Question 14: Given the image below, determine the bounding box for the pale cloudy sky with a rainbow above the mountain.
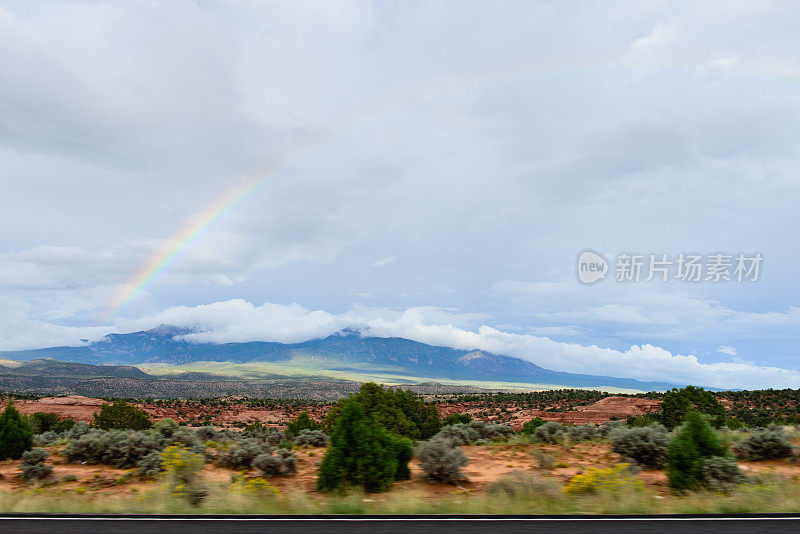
[0,0,800,388]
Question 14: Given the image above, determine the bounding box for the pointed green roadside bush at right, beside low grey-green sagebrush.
[667,412,727,493]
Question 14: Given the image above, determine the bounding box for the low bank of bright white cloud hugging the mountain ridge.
[108,300,800,388]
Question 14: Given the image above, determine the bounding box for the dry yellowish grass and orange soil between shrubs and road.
[0,440,800,514]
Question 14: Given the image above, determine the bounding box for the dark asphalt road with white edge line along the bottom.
[0,516,800,534]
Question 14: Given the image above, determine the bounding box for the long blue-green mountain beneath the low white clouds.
[0,326,676,390]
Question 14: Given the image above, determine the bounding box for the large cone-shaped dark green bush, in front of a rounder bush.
[317,399,410,492]
